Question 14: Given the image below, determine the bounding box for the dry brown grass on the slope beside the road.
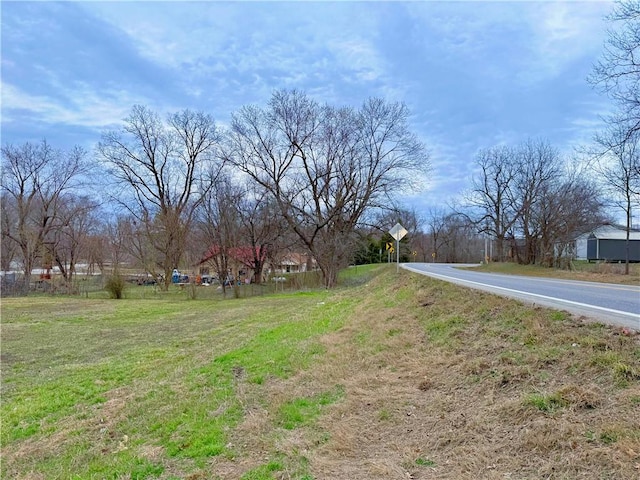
[215,276,640,480]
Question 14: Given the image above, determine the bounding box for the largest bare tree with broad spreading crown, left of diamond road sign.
[225,91,428,287]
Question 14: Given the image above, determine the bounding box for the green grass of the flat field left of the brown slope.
[0,269,365,478]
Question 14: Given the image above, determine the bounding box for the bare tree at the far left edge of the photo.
[2,140,88,286]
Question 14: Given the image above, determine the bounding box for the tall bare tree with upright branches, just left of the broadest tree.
[98,105,220,288]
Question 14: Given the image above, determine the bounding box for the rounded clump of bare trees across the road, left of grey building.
[464,140,603,266]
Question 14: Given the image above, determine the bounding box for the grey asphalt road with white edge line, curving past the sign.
[401,263,640,330]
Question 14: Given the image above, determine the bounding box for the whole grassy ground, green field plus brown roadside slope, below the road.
[0,266,640,480]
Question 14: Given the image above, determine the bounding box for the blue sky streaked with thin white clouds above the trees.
[0,1,613,210]
